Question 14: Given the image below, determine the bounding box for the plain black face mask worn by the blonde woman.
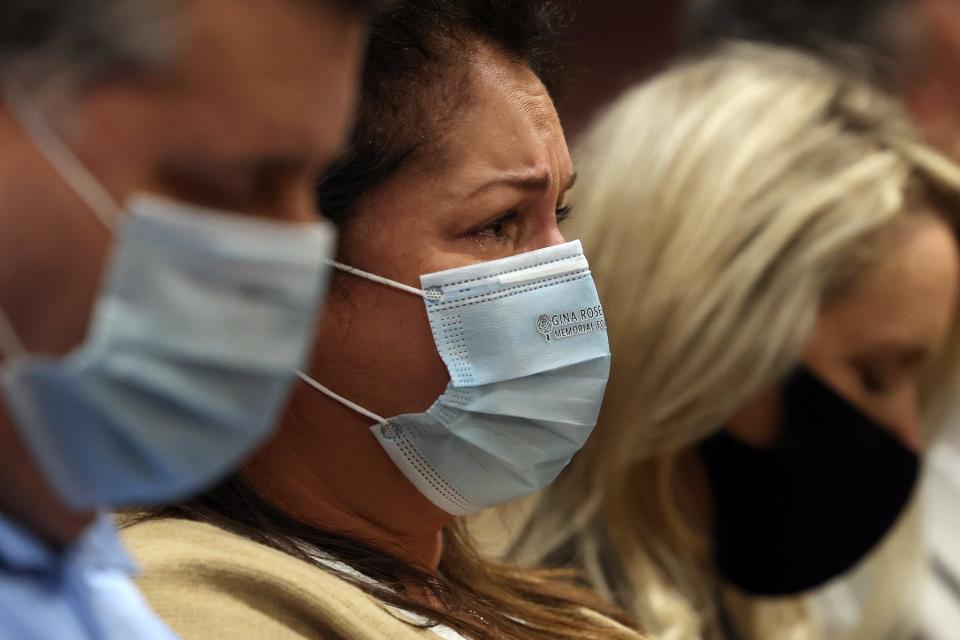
[698,367,920,596]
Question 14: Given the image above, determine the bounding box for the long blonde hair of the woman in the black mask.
[513,43,960,640]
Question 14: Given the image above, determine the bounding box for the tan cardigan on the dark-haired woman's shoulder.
[122,519,640,640]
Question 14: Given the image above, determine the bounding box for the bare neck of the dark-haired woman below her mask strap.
[243,390,452,571]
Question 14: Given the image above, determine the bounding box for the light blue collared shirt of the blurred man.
[0,516,176,640]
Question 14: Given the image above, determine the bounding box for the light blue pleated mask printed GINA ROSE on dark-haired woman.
[301,241,610,515]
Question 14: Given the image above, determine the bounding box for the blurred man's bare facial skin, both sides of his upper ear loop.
[0,0,365,353]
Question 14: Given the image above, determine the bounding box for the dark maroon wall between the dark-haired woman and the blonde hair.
[558,0,681,137]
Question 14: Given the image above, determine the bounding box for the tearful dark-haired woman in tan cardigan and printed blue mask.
[126,0,637,640]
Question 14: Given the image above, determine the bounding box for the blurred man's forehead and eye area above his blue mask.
[65,0,363,220]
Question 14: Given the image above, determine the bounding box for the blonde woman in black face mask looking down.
[502,44,960,640]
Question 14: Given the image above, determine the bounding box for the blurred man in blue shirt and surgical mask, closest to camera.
[0,0,388,640]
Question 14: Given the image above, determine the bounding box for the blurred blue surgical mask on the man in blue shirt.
[0,89,335,509]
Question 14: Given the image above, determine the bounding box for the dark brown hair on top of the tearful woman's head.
[317,0,567,225]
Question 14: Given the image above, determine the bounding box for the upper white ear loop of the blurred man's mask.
[5,86,120,232]
